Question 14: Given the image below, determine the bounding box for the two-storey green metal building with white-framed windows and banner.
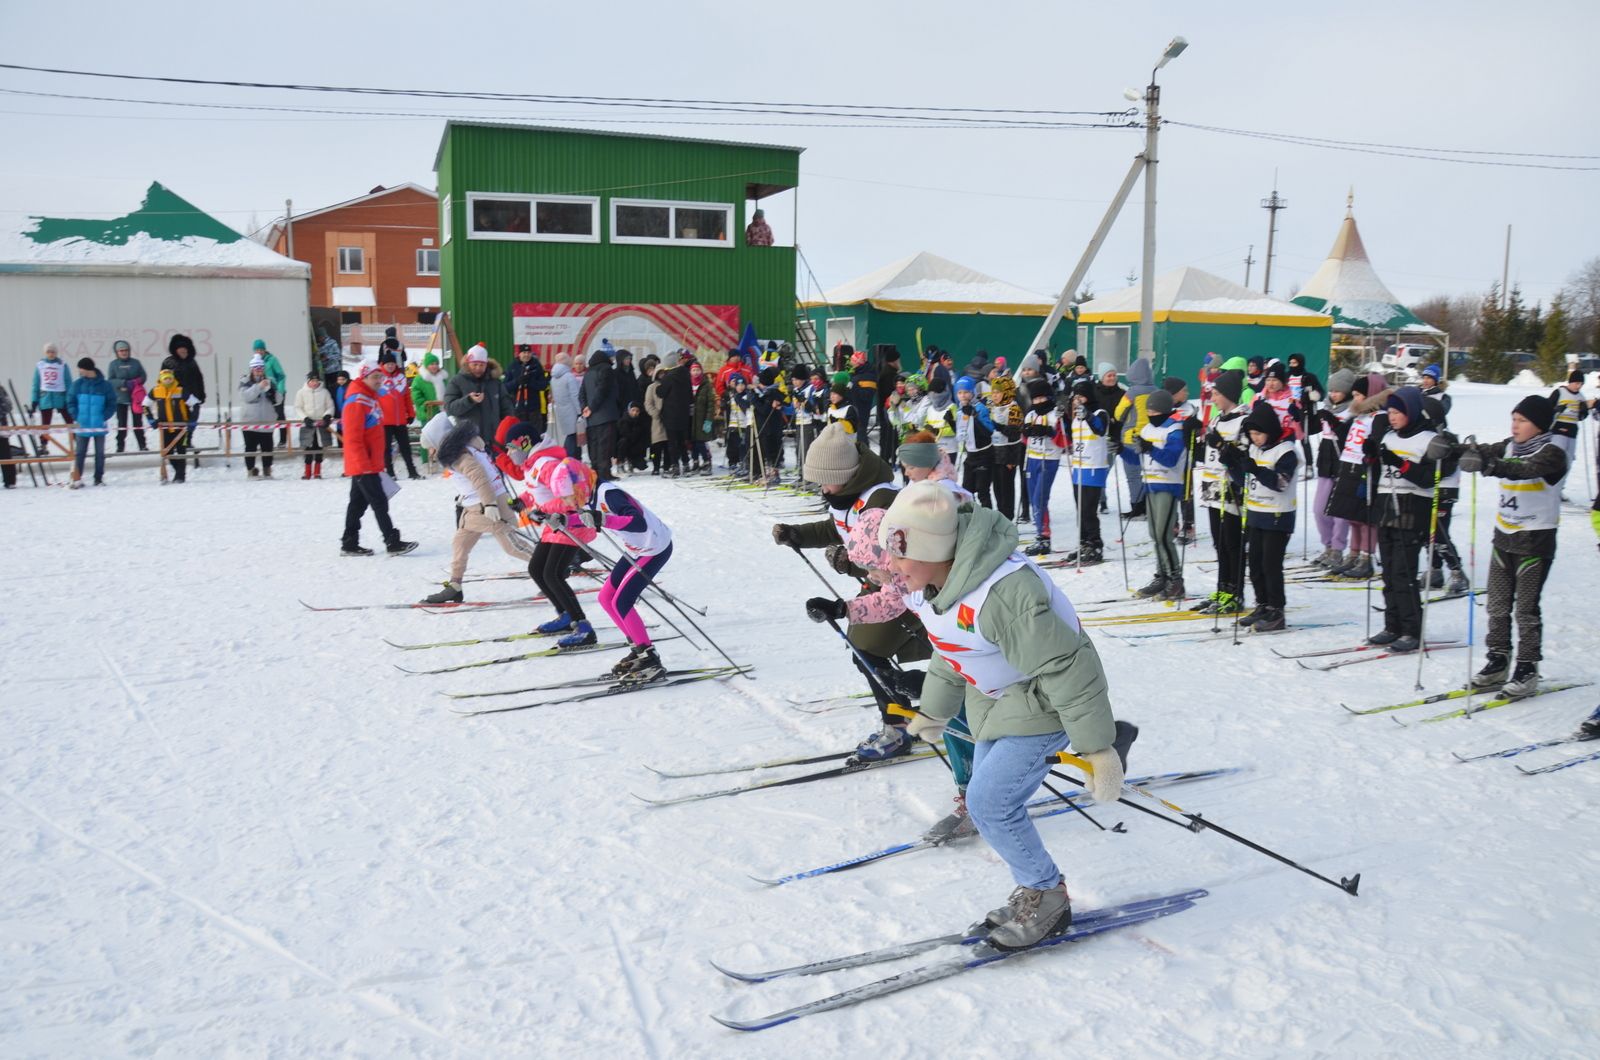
[434,122,802,362]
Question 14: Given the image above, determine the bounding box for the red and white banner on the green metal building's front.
[510,303,739,365]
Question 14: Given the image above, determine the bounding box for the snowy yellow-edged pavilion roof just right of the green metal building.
[805,251,1054,317]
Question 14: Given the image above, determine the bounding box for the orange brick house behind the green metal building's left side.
[266,184,438,325]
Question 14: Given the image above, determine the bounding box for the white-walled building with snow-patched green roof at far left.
[0,184,310,408]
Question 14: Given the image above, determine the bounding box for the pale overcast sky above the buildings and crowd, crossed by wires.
[0,0,1600,313]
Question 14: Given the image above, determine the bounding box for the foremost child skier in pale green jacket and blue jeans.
[878,486,1125,950]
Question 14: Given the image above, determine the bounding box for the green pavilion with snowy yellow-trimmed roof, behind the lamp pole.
[1077,269,1333,381]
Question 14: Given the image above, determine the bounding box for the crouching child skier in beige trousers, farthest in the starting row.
[422,415,533,604]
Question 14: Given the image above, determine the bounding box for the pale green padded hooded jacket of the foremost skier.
[912,506,1115,754]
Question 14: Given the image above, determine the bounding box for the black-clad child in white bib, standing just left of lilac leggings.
[1222,402,1299,632]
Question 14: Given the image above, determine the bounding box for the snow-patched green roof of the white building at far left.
[0,183,309,277]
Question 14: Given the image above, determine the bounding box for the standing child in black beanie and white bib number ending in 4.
[1429,395,1568,697]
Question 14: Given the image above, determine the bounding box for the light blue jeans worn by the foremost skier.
[966,732,1069,890]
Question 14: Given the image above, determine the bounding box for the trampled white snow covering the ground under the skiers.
[0,386,1600,1057]
